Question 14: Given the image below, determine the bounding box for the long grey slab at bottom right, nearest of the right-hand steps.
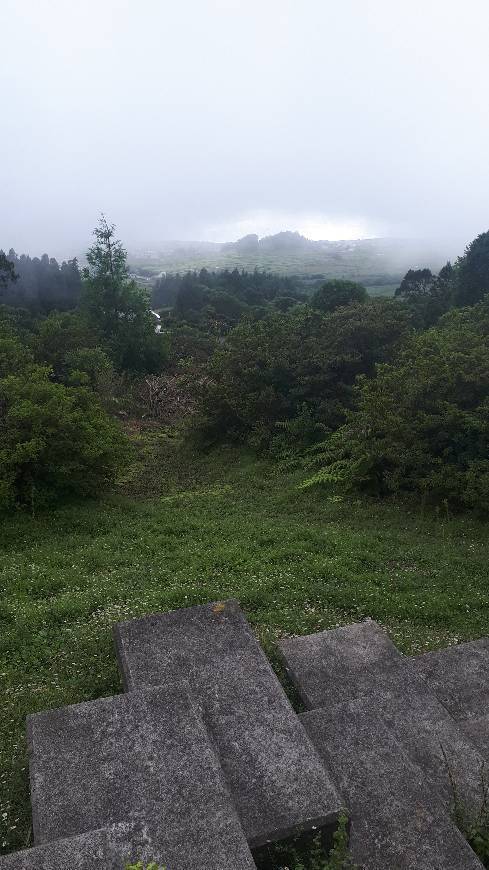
[300,698,482,870]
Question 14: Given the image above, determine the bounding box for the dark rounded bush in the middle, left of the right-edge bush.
[200,300,409,443]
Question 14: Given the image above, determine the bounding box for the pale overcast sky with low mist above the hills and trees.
[0,0,489,254]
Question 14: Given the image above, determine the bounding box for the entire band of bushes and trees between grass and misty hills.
[0,217,489,510]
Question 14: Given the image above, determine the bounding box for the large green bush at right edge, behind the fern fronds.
[308,302,489,511]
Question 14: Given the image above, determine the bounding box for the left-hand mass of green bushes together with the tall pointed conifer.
[0,218,166,511]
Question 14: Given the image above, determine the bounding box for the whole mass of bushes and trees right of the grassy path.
[195,232,489,511]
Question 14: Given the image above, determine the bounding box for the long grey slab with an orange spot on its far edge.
[115,601,342,848]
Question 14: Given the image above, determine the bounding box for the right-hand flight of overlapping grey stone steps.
[280,620,489,870]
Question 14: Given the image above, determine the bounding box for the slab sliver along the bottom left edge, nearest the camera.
[0,818,255,870]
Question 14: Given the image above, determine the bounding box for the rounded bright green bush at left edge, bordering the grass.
[0,366,129,509]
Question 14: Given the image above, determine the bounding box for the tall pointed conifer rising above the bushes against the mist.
[82,215,166,372]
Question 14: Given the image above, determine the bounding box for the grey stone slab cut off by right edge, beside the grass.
[412,637,489,719]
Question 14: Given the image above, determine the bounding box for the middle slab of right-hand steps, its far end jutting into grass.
[280,621,484,811]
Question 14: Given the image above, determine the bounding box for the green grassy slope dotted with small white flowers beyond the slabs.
[0,439,489,851]
